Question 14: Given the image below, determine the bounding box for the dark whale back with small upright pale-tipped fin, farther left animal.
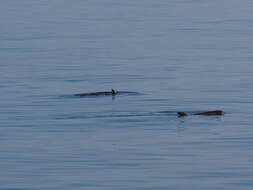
[74,88,139,97]
